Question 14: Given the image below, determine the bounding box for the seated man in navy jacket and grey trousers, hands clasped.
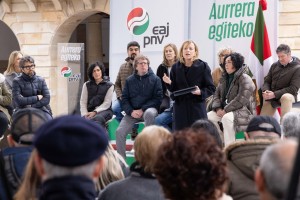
[116,55,163,158]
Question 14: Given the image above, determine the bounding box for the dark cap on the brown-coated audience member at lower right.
[246,116,281,136]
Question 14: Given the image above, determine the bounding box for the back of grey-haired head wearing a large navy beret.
[33,115,108,180]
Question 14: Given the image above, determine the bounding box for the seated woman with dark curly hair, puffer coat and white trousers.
[207,53,256,146]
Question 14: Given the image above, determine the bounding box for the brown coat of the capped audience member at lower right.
[225,139,276,200]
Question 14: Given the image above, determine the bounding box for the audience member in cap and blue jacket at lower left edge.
[0,108,47,199]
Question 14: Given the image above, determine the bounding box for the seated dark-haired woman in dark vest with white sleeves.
[80,62,114,127]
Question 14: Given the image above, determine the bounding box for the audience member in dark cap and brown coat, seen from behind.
[225,116,281,200]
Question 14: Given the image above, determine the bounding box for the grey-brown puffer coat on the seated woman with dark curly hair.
[212,65,256,132]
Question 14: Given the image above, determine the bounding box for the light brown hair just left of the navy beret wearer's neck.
[14,150,41,200]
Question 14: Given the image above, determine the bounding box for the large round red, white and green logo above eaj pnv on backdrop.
[127,7,149,35]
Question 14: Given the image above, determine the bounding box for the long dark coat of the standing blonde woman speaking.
[167,59,215,130]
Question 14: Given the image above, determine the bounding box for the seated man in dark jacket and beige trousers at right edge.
[260,44,300,120]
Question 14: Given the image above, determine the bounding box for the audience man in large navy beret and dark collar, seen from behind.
[34,115,108,200]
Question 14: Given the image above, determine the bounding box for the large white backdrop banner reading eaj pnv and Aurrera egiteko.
[109,0,278,82]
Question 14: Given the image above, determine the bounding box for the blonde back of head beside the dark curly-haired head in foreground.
[134,125,171,173]
